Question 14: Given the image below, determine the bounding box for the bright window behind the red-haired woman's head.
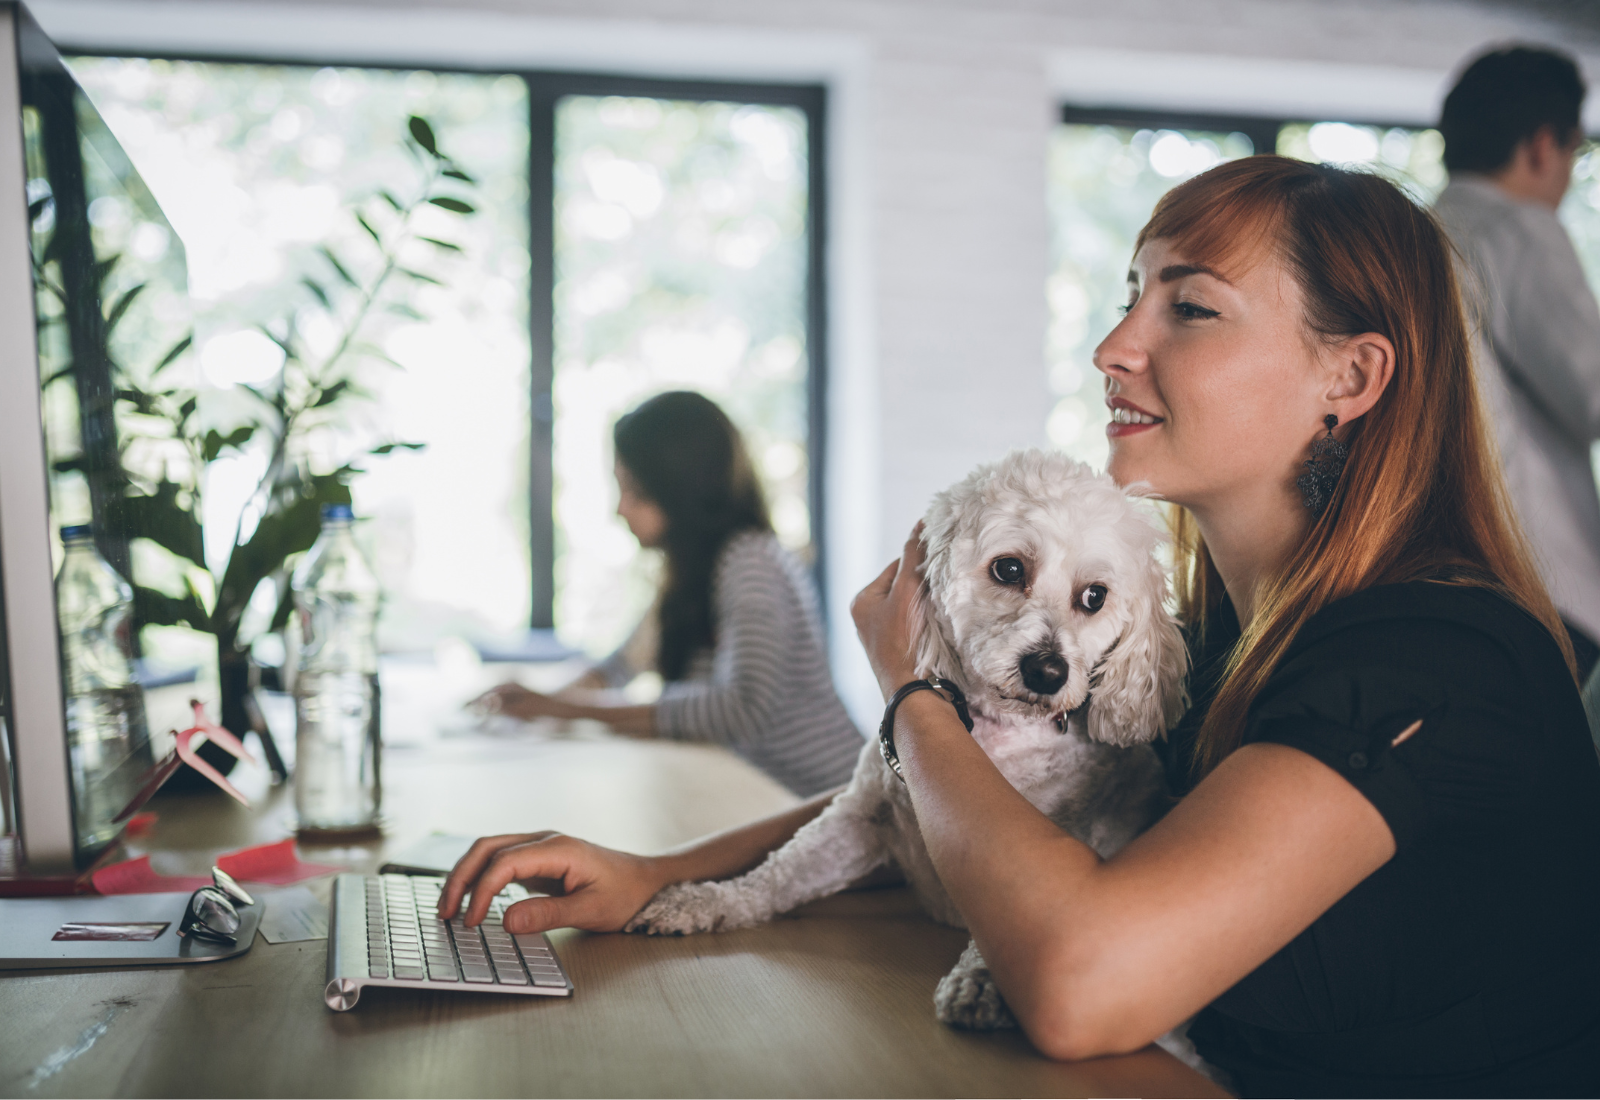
[1046,107,1600,465]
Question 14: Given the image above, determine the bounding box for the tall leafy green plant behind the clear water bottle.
[117,117,474,788]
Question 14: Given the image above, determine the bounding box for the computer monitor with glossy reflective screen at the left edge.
[0,0,190,876]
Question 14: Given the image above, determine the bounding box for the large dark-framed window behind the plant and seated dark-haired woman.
[72,58,822,665]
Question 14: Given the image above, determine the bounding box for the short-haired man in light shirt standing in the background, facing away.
[1435,46,1600,676]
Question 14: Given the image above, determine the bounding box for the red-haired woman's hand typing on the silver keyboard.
[438,831,667,934]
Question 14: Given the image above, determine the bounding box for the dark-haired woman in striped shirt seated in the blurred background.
[474,390,862,796]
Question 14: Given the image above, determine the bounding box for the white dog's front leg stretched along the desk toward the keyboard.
[624,787,890,935]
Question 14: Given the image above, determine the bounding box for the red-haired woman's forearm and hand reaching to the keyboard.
[438,788,842,932]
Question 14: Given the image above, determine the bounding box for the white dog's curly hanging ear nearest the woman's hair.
[1088,555,1189,745]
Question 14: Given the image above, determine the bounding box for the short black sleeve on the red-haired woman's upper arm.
[1243,620,1538,849]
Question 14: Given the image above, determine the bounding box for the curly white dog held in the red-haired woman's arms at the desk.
[627,451,1187,1028]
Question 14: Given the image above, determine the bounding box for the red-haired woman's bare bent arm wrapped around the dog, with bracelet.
[851,534,1395,1058]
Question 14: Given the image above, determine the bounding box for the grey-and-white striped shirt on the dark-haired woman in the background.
[600,531,862,796]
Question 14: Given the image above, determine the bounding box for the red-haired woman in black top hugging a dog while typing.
[440,155,1600,1097]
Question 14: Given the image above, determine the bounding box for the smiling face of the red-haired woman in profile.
[1094,240,1330,510]
